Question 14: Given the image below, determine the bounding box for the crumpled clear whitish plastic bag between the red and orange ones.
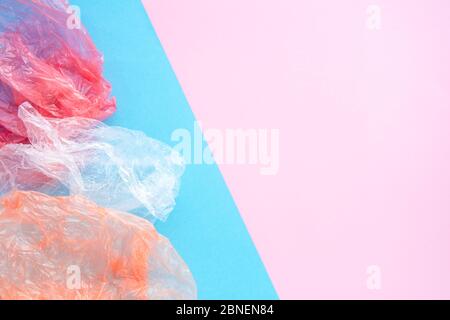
[0,103,184,220]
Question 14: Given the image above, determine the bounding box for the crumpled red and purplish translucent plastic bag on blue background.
[0,0,116,146]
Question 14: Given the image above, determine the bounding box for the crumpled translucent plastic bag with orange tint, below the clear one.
[0,191,196,300]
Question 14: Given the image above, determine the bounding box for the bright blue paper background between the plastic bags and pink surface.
[71,0,278,299]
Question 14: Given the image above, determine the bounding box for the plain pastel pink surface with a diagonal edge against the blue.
[143,0,450,299]
